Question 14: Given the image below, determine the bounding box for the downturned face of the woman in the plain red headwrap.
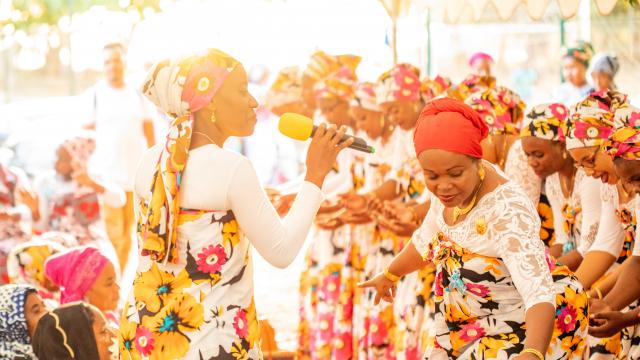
[418,149,479,208]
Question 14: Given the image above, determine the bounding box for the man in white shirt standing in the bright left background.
[88,43,155,271]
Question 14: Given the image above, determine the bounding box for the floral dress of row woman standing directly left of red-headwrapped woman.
[354,129,434,359]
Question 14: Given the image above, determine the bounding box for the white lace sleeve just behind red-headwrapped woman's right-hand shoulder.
[504,140,542,206]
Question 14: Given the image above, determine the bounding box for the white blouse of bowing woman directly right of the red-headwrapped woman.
[545,169,600,256]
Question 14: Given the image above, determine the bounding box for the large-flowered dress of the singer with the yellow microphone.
[120,203,261,359]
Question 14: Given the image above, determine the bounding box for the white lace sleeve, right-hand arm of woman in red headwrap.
[487,185,556,309]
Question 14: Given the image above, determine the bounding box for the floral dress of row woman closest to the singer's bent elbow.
[298,148,358,359]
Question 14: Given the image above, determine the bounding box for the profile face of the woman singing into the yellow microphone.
[209,65,258,137]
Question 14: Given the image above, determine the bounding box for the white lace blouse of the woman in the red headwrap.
[412,182,557,309]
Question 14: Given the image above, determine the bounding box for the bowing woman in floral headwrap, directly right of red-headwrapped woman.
[520,104,601,258]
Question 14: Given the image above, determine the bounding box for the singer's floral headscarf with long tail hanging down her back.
[141,49,240,263]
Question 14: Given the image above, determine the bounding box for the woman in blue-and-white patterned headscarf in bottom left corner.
[0,285,47,360]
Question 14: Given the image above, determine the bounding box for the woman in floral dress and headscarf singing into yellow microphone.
[119,49,351,359]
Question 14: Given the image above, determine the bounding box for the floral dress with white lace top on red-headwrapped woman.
[412,183,588,360]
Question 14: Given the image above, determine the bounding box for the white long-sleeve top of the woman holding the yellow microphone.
[135,144,323,268]
